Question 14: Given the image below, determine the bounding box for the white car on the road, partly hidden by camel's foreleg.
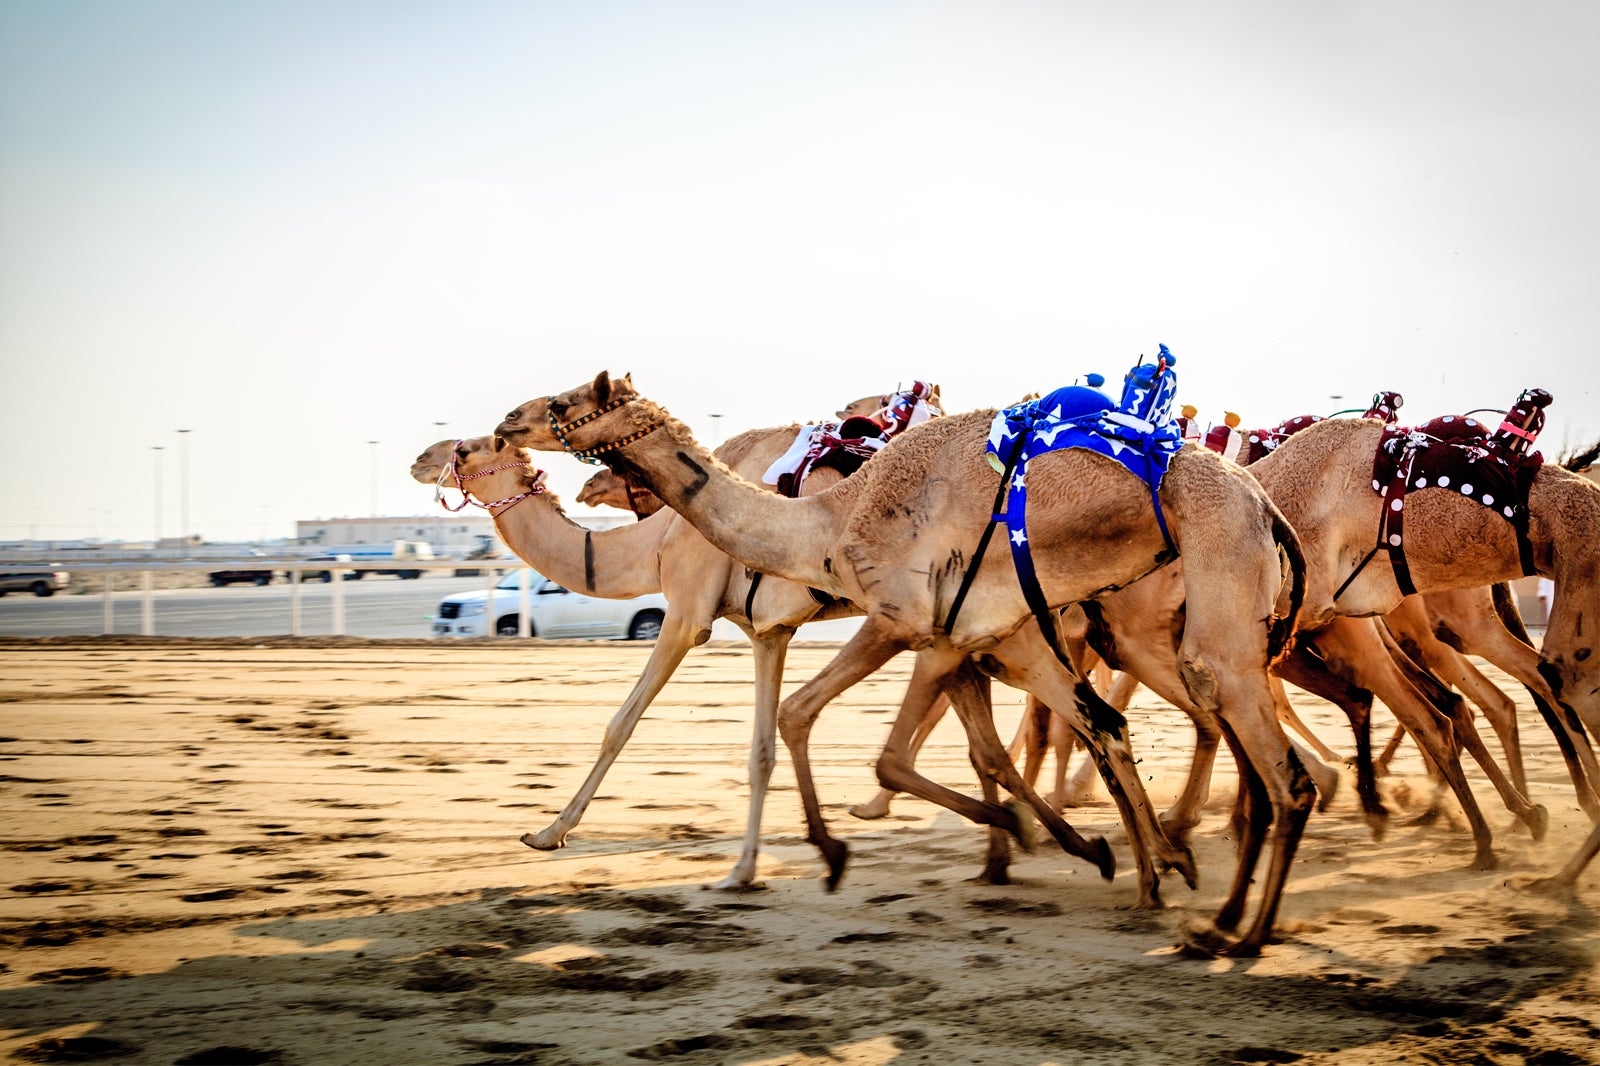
[434,570,667,640]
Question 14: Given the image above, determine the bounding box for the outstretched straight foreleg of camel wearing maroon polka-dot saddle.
[1317,618,1498,869]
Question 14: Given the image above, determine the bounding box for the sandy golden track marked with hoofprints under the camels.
[0,637,1600,1066]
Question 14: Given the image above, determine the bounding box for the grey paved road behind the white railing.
[0,573,861,640]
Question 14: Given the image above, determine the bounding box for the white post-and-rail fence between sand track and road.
[10,555,533,637]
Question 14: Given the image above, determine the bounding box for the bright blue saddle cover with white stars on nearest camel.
[987,344,1184,598]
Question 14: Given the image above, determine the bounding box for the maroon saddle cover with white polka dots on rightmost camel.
[1363,389,1550,595]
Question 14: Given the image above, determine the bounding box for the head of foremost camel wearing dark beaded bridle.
[494,370,667,463]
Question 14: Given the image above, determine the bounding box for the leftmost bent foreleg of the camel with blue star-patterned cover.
[778,615,908,892]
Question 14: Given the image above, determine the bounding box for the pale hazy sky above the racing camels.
[0,0,1600,541]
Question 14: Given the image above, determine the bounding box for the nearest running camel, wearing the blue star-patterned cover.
[494,371,1314,954]
